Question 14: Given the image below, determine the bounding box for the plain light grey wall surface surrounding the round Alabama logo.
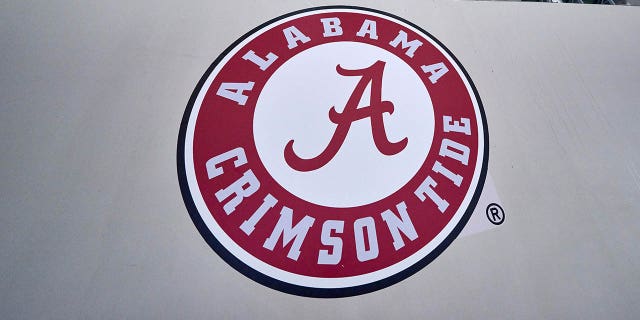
[0,1,640,319]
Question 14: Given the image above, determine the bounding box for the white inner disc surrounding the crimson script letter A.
[253,42,434,208]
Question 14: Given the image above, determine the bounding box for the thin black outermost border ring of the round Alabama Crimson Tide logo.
[177,6,489,298]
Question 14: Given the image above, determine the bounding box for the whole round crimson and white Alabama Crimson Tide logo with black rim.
[178,7,488,297]
